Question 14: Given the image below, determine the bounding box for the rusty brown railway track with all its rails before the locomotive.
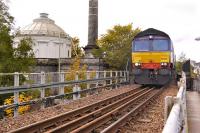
[11,87,161,133]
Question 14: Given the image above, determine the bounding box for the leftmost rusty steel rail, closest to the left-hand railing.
[11,87,141,133]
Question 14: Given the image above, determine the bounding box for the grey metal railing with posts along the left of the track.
[0,71,129,116]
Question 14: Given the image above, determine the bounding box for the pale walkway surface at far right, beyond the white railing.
[186,91,200,133]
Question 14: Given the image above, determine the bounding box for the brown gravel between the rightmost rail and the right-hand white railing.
[121,85,178,133]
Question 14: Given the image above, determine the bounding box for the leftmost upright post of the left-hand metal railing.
[14,72,19,117]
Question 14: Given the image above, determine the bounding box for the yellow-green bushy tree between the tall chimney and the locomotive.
[93,24,140,70]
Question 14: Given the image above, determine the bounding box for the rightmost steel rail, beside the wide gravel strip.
[101,90,162,133]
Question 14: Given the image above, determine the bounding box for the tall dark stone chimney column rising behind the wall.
[84,0,98,57]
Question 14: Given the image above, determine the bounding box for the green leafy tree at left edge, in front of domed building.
[0,0,35,104]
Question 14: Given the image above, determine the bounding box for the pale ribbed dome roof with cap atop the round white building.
[20,13,69,38]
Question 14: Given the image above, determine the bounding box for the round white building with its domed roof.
[14,13,71,59]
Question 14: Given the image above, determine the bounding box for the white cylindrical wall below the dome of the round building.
[13,36,71,58]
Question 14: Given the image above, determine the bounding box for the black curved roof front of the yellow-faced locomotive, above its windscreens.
[135,28,170,38]
